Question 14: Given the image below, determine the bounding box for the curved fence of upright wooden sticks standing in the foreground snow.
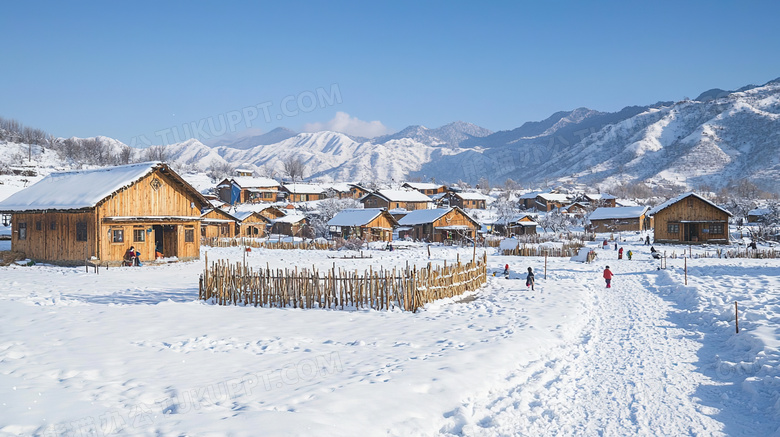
[198,254,487,312]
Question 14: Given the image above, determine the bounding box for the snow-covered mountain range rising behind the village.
[0,80,780,192]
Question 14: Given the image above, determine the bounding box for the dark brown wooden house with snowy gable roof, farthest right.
[648,193,731,244]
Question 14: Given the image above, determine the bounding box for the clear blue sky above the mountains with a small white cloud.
[0,1,780,145]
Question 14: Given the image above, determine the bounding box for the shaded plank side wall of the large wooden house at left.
[11,210,97,264]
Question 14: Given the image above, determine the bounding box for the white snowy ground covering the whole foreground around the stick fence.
[0,240,780,436]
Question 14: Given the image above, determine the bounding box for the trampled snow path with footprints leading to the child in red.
[442,261,723,436]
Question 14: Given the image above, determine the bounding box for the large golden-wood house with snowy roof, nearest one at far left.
[0,162,209,265]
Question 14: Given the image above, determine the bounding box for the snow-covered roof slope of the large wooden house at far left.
[0,162,165,211]
